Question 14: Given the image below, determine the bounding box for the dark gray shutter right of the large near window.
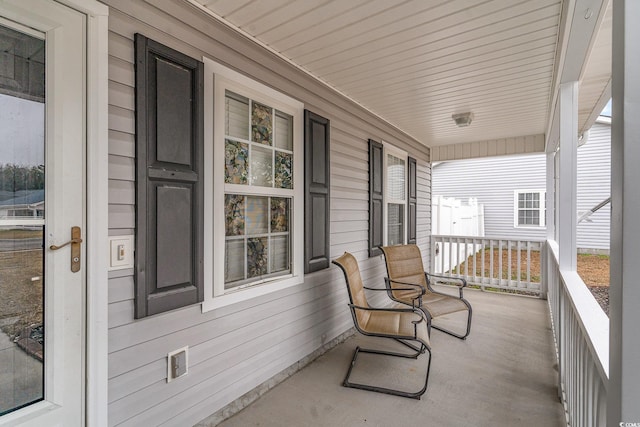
[304,110,330,273]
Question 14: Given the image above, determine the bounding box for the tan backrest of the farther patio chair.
[380,245,429,292]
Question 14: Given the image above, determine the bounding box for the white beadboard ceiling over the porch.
[196,0,611,150]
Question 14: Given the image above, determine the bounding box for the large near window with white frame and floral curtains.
[203,58,304,310]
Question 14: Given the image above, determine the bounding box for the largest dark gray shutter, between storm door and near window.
[135,34,204,318]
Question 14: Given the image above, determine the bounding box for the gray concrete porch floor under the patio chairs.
[220,290,565,427]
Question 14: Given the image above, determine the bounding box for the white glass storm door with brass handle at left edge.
[0,0,85,426]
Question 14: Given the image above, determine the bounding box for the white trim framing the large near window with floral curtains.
[202,57,304,312]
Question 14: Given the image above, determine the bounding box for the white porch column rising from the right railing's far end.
[556,82,578,271]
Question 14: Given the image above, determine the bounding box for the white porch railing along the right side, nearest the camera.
[543,241,609,427]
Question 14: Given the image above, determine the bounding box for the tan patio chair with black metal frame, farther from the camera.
[380,245,472,340]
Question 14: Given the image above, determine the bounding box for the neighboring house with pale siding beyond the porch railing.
[432,117,611,252]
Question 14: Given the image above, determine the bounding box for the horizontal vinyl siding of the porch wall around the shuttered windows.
[105,0,431,426]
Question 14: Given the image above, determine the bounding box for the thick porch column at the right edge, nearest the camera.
[607,0,640,426]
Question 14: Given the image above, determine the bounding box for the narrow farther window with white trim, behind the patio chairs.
[384,146,407,245]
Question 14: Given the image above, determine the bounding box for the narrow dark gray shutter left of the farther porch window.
[369,139,384,257]
